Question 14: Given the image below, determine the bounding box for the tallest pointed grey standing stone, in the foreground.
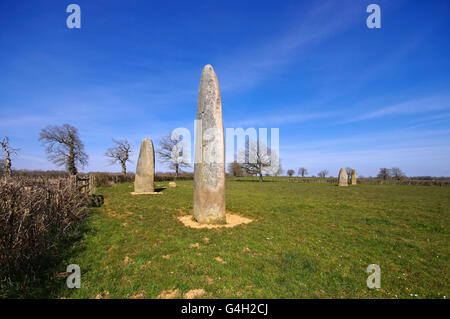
[194,64,226,224]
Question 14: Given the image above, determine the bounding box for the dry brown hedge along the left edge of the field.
[0,177,89,279]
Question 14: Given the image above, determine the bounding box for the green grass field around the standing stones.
[14,179,450,298]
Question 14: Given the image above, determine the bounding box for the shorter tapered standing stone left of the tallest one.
[134,138,155,194]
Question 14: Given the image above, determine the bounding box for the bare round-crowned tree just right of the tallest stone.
[242,140,281,182]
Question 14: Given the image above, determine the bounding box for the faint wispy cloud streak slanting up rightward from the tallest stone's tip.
[218,1,358,91]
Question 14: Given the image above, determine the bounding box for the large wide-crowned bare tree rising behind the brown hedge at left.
[39,124,88,175]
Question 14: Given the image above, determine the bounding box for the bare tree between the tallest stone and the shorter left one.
[156,135,191,179]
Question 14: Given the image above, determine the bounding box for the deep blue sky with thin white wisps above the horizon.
[0,0,450,176]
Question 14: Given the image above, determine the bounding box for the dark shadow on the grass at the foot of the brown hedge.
[0,216,95,299]
